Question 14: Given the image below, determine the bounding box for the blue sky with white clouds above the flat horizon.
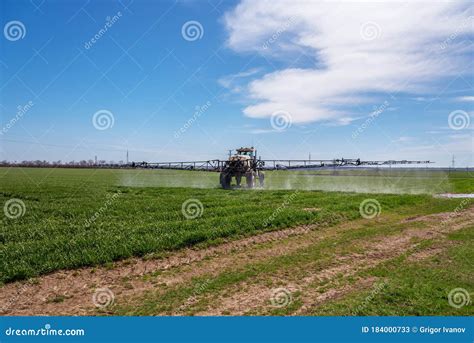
[0,0,474,166]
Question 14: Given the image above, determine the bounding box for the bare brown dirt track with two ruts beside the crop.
[0,207,474,315]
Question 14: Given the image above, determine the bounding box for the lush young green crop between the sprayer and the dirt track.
[0,168,470,282]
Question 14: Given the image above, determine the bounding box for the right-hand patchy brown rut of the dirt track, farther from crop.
[195,207,474,316]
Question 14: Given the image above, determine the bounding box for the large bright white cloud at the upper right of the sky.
[224,0,474,123]
